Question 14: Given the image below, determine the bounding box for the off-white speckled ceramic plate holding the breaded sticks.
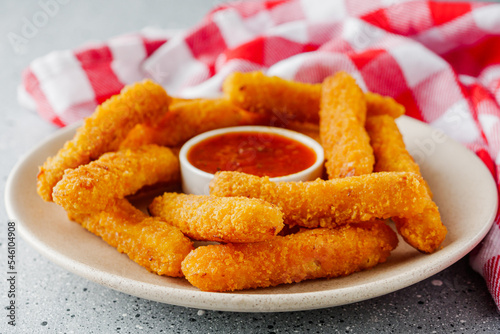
[5,117,497,312]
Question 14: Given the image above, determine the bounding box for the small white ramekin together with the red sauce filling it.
[179,126,324,195]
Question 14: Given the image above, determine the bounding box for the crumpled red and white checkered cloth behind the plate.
[20,0,500,306]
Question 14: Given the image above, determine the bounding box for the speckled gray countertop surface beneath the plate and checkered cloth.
[0,0,500,333]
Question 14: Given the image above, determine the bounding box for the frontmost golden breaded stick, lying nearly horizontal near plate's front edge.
[182,222,398,292]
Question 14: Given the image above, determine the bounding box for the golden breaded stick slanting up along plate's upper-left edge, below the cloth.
[37,80,171,201]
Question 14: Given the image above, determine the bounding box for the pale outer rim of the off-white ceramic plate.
[4,116,498,312]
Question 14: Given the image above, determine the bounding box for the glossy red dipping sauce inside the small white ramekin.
[187,132,316,177]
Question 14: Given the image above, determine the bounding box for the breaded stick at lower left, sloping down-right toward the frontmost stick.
[69,199,193,277]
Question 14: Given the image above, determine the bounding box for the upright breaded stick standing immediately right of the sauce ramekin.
[319,72,375,179]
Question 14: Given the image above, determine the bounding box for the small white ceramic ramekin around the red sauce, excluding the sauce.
[179,126,325,195]
